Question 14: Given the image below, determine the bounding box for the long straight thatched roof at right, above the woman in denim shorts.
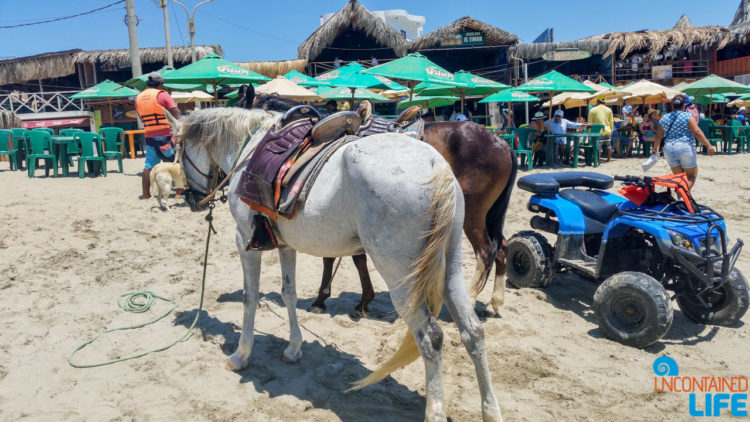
[601,26,732,58]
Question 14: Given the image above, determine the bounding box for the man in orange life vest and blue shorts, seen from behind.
[135,72,182,199]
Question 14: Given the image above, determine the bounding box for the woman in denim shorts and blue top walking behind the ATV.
[654,95,716,189]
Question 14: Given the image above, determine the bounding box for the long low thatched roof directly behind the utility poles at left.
[74,45,223,66]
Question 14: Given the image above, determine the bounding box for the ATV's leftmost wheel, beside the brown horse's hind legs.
[505,230,554,288]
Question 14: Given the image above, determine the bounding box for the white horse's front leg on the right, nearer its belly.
[279,246,302,363]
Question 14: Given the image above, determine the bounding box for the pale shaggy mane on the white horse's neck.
[180,107,281,157]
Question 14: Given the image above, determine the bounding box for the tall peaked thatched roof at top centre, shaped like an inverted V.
[297,0,406,61]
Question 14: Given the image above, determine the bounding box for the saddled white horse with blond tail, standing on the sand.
[180,108,502,421]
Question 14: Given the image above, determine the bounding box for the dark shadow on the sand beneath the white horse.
[174,308,425,421]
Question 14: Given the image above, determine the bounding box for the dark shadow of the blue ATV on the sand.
[543,273,718,353]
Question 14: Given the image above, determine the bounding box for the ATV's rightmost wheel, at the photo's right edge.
[677,268,750,326]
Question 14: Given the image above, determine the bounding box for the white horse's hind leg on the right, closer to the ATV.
[445,221,503,422]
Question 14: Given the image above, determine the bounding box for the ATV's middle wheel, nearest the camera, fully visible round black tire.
[593,271,673,347]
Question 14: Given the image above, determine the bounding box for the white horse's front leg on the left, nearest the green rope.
[227,229,261,371]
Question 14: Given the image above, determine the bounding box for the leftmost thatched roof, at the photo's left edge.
[0,49,81,85]
